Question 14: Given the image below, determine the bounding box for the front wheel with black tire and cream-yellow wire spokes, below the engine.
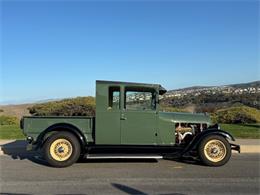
[198,135,231,166]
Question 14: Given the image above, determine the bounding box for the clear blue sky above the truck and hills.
[0,0,260,103]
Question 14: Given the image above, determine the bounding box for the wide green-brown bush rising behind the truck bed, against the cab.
[28,97,95,116]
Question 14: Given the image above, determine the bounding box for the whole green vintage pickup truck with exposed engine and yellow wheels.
[21,81,240,167]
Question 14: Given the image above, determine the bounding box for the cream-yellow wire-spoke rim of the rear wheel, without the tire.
[50,139,73,161]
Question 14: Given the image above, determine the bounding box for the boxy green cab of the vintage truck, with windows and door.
[95,81,167,145]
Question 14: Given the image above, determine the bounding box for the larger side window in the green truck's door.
[125,88,156,110]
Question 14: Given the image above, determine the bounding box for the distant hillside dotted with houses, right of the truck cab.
[164,81,260,112]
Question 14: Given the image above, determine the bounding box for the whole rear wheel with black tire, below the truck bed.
[43,131,80,167]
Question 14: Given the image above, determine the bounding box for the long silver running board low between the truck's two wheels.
[85,154,163,159]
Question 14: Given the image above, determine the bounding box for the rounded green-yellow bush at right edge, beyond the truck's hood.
[212,106,260,124]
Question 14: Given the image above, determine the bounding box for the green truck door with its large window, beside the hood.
[120,87,158,145]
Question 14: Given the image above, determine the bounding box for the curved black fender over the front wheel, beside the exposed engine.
[182,129,235,154]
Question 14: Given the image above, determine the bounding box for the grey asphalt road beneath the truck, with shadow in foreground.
[0,154,260,195]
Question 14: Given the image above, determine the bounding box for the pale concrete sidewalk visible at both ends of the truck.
[0,139,260,155]
